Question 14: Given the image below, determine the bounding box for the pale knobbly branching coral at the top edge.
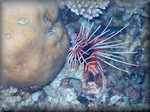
[58,0,110,20]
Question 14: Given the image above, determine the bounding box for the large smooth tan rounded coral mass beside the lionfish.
[1,0,69,88]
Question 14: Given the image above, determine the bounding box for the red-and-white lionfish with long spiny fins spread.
[67,19,137,76]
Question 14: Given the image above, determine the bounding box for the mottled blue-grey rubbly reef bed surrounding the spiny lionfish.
[0,0,150,112]
